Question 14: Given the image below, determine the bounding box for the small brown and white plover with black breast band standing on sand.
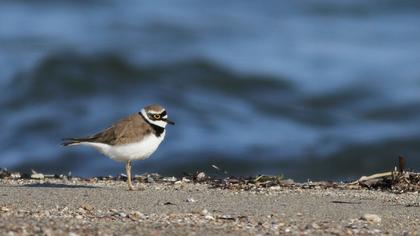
[62,104,175,190]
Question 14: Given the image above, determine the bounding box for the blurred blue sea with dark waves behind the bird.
[0,0,420,180]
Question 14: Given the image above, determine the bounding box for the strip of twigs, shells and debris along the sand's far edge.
[0,159,420,194]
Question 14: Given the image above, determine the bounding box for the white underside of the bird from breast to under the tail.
[80,131,166,161]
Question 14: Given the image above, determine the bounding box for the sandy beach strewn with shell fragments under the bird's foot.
[0,174,420,236]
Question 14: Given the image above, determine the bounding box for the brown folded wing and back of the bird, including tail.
[64,113,152,145]
